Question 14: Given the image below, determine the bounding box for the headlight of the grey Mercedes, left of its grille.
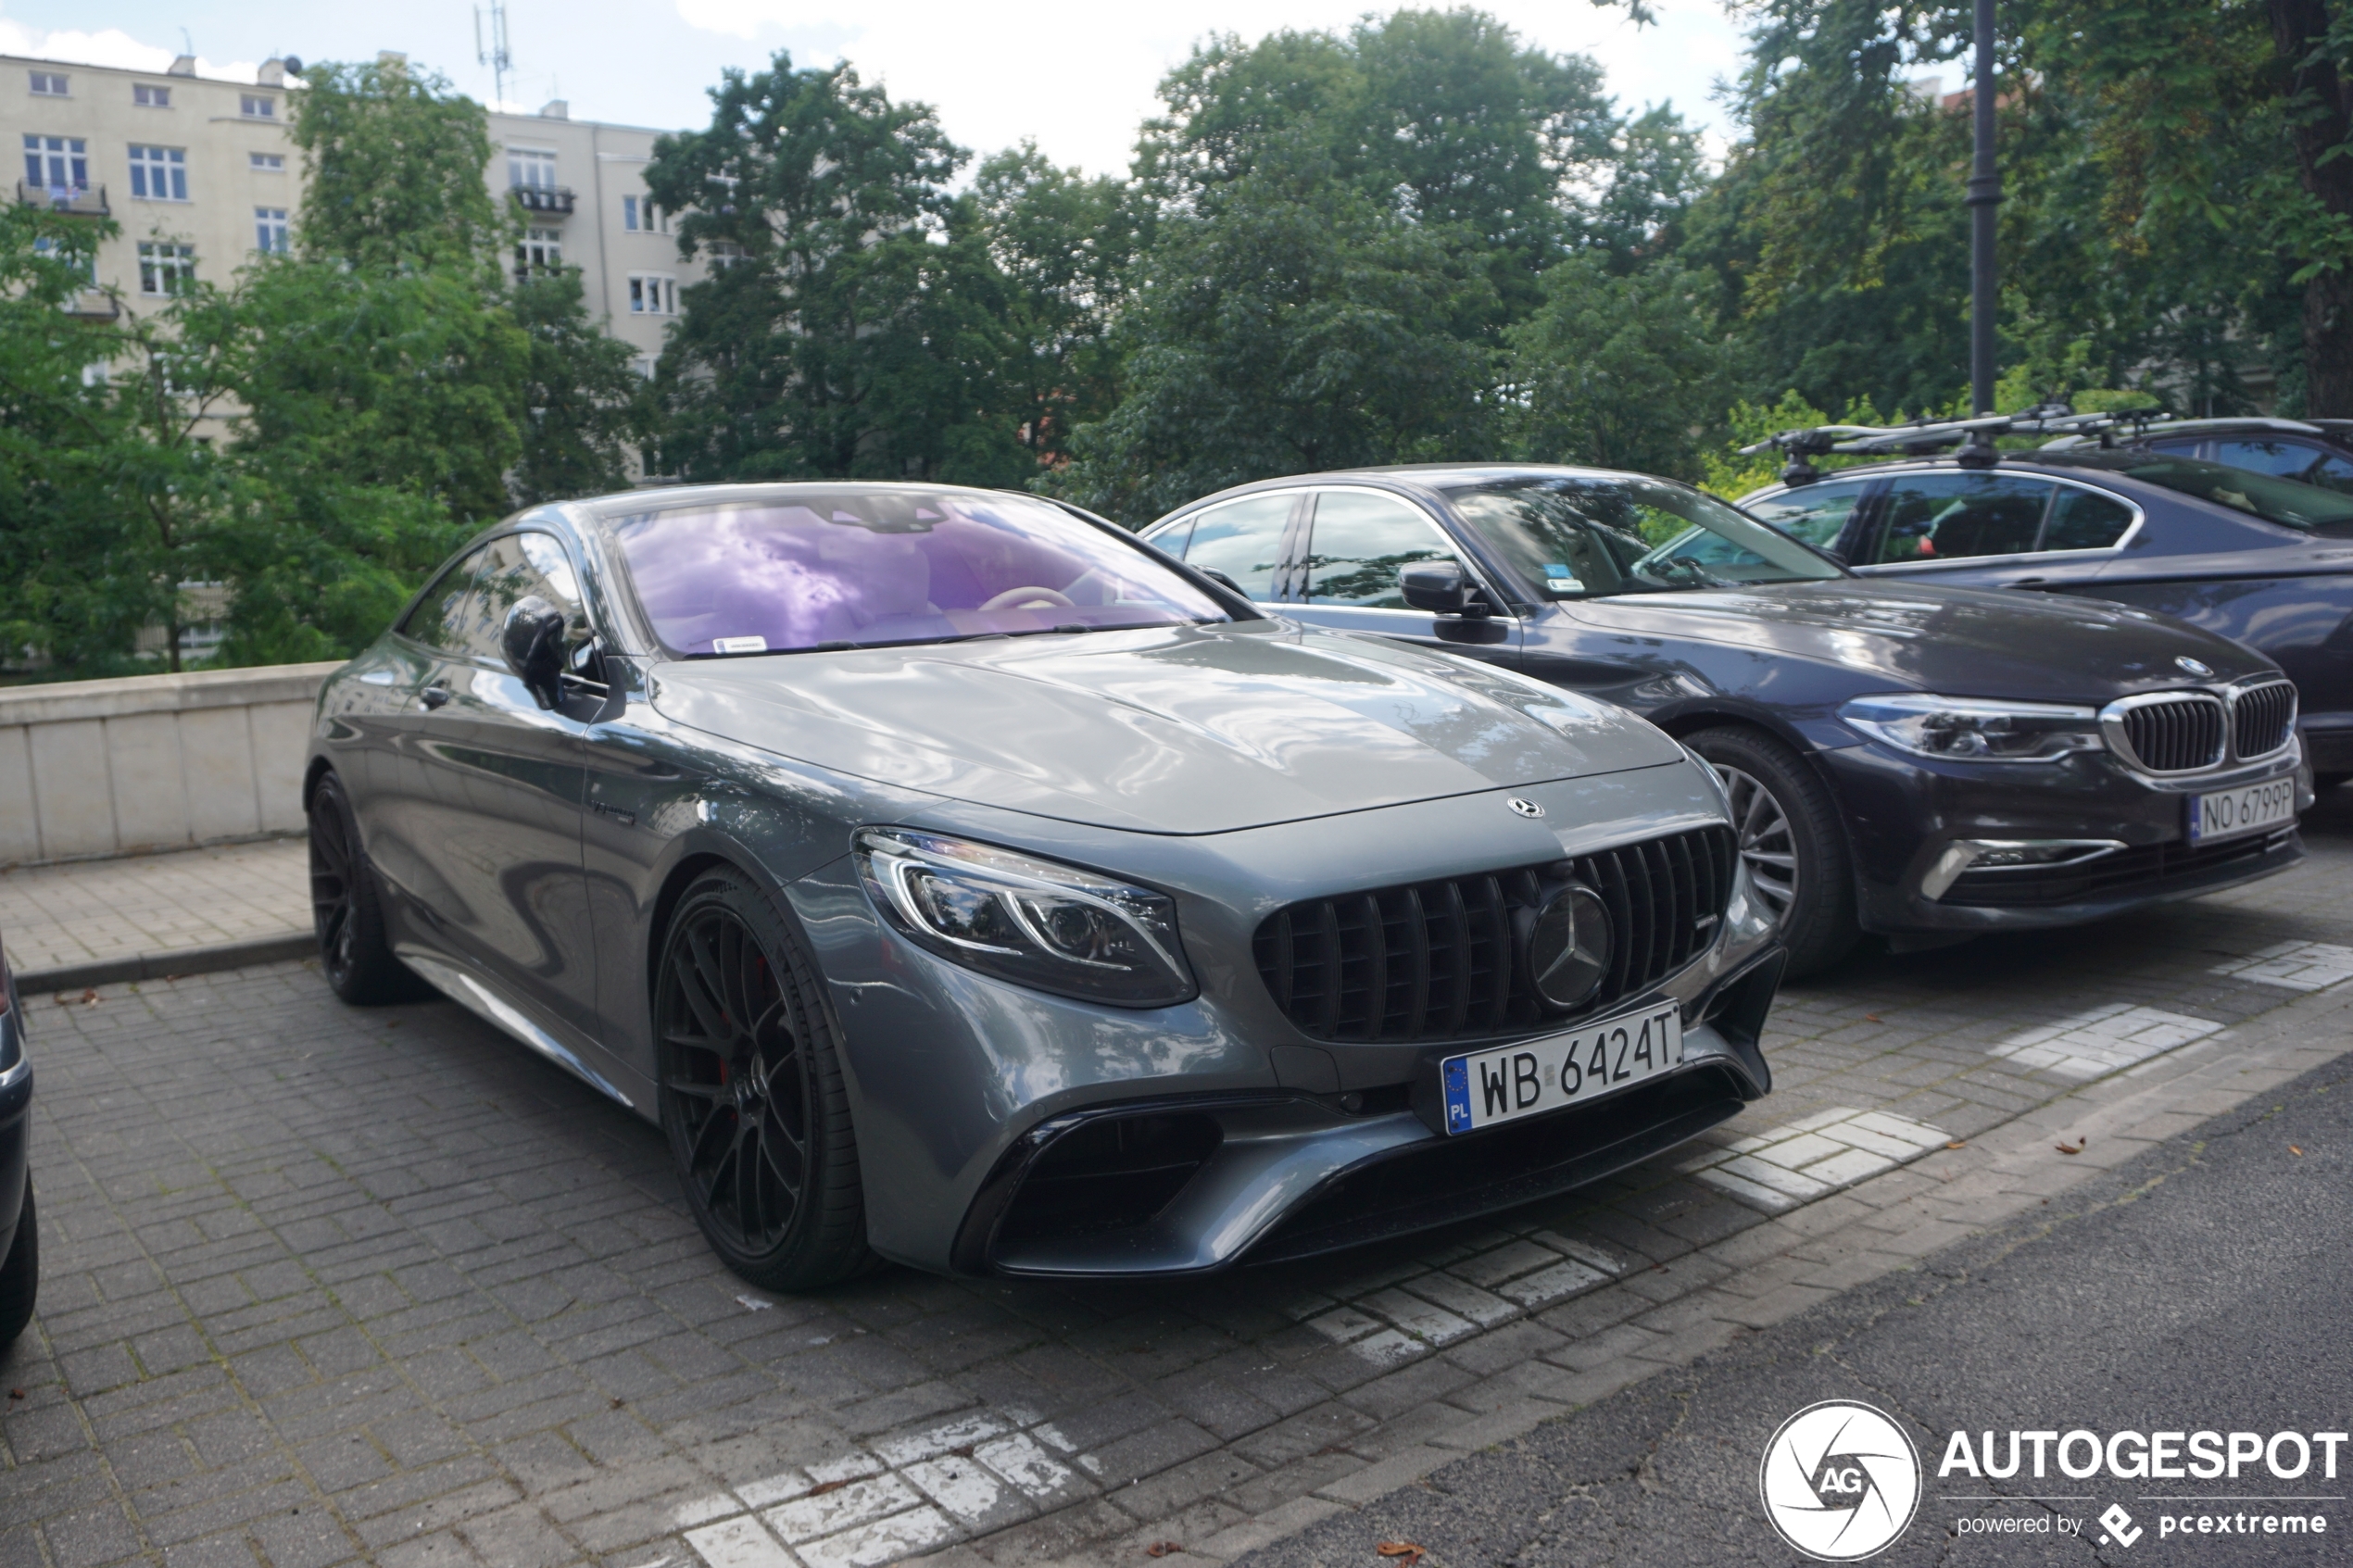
[851,827,1193,1006]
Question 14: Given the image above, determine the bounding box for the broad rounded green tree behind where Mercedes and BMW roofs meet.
[1045,148,1494,521]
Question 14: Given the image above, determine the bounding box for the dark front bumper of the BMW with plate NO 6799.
[1817,743,2313,935]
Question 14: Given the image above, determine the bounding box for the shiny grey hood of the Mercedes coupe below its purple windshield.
[652,623,1682,834]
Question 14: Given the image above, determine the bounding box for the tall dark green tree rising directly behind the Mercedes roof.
[645,54,1031,484]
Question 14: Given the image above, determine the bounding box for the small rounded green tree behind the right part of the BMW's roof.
[1506,254,1737,480]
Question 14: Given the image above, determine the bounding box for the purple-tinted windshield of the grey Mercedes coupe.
[611,486,1230,659]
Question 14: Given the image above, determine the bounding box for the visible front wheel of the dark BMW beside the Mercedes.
[1682,724,1861,980]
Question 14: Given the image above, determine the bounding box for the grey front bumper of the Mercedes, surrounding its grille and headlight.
[786,759,1769,1274]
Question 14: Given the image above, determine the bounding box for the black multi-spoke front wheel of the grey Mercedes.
[654,868,875,1293]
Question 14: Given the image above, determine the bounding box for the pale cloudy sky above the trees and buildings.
[0,0,1739,174]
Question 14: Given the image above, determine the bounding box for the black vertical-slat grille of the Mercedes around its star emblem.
[1254,827,1734,1044]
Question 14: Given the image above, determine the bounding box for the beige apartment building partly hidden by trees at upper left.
[0,54,701,370]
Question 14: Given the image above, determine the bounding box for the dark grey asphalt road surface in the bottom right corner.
[1242,1060,2353,1568]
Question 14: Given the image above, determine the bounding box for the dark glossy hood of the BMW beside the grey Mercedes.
[1563,578,2275,703]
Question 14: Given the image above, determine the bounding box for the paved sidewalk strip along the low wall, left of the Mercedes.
[0,839,310,975]
